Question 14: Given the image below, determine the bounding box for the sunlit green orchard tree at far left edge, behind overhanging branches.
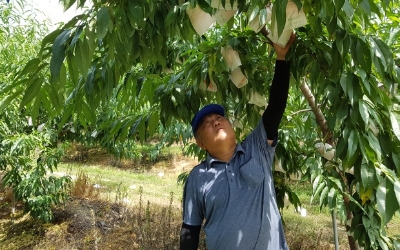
[0,2,70,221]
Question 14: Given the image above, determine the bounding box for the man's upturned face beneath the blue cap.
[196,114,236,151]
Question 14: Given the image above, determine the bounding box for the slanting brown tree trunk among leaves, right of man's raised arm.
[300,81,359,250]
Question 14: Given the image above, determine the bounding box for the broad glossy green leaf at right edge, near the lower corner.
[376,178,400,225]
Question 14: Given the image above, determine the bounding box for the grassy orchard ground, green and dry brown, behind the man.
[0,145,400,250]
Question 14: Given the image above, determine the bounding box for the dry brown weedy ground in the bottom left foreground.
[0,179,180,250]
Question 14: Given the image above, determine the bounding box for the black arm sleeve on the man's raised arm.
[262,60,290,140]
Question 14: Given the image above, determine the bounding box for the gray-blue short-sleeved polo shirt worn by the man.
[183,121,288,250]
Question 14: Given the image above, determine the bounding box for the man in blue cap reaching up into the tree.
[180,34,295,250]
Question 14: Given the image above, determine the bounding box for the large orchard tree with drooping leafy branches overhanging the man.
[1,0,400,249]
